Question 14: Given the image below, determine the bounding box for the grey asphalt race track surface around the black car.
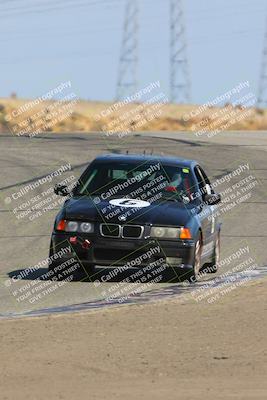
[0,132,267,318]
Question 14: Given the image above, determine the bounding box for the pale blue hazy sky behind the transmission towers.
[0,0,267,103]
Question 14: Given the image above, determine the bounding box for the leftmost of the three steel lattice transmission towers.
[116,0,138,100]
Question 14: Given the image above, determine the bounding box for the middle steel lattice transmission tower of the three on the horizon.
[170,0,191,103]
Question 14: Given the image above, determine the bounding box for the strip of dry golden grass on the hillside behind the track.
[0,99,267,134]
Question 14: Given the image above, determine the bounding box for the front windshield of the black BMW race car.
[73,162,194,203]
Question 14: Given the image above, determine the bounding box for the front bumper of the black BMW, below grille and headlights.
[51,232,195,270]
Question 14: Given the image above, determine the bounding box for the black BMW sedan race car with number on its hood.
[49,154,221,282]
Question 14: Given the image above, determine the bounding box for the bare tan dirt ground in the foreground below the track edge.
[0,279,267,400]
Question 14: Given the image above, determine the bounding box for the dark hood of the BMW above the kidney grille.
[64,197,192,226]
